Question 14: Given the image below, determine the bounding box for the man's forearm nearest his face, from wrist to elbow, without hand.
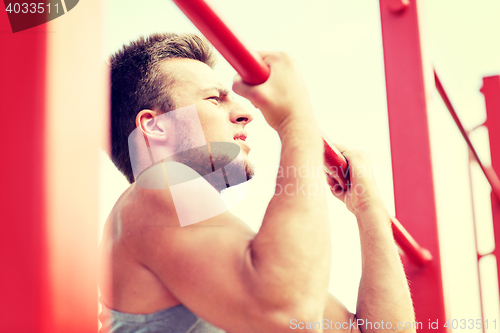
[252,117,330,315]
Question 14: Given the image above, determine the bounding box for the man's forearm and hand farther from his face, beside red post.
[329,145,415,333]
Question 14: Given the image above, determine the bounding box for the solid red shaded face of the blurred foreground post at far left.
[0,11,50,333]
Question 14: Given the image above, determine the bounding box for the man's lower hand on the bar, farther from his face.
[326,143,384,215]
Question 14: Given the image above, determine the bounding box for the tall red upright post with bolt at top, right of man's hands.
[380,0,446,333]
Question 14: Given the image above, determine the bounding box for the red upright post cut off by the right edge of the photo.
[481,75,500,302]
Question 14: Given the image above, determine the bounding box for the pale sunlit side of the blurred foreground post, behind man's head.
[45,1,109,333]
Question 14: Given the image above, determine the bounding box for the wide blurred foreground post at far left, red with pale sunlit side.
[0,3,104,333]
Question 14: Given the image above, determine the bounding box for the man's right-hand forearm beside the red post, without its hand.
[356,204,415,333]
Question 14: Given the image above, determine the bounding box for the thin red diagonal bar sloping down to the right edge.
[434,71,500,200]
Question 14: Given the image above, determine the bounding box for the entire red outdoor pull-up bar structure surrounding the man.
[0,0,500,333]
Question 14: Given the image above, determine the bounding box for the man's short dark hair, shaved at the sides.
[110,33,216,183]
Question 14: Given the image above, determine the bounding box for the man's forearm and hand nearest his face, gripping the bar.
[233,53,330,322]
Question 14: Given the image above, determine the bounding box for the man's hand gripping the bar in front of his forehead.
[233,52,312,133]
